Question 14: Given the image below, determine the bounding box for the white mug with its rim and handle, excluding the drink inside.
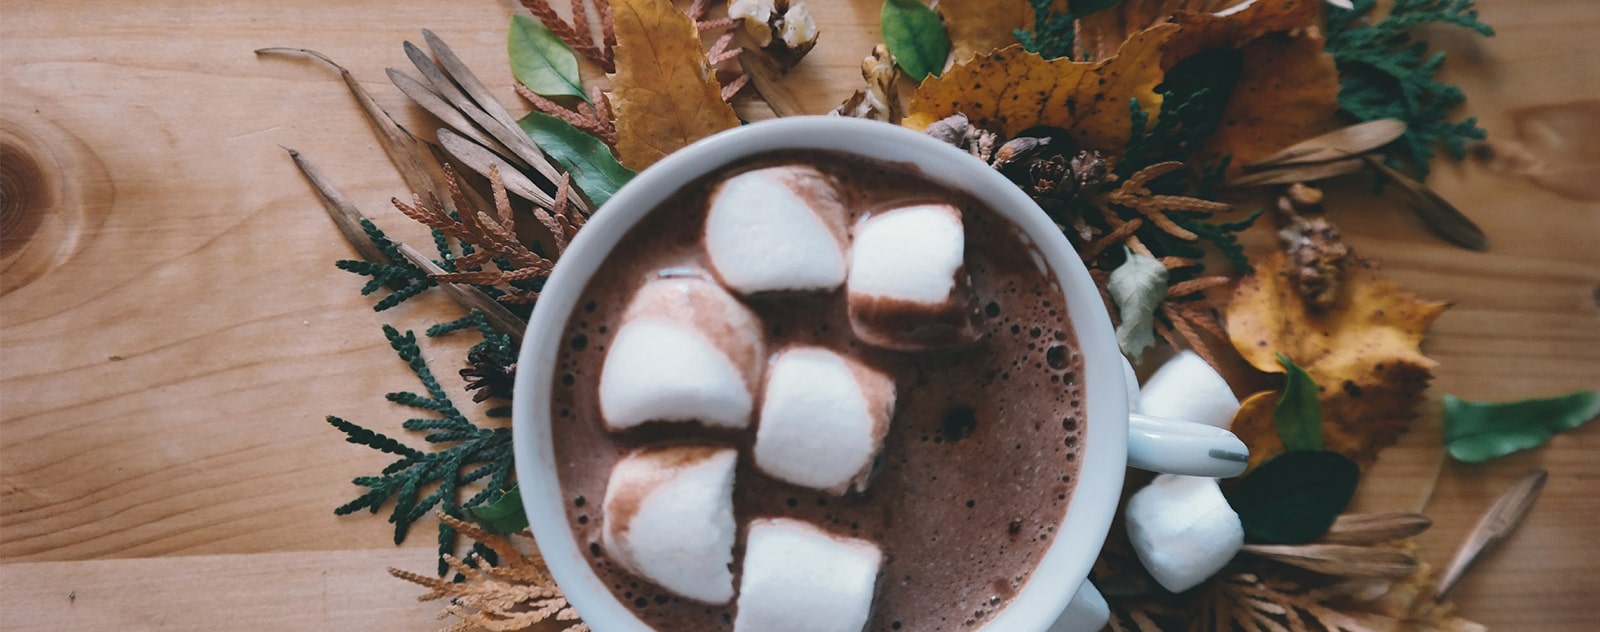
[512,117,1246,632]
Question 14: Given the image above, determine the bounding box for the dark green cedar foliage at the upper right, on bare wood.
[1326,0,1494,181]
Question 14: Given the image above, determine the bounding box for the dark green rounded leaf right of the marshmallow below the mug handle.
[1227,450,1362,544]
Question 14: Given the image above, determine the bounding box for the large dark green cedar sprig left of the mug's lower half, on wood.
[328,324,512,574]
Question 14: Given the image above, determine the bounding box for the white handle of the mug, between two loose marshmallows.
[1128,413,1250,478]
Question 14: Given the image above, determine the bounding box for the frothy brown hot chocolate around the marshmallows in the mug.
[550,152,1085,632]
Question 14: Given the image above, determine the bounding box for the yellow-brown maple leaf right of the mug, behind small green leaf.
[1227,253,1448,467]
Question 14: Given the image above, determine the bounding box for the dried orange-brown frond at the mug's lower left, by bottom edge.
[389,515,589,632]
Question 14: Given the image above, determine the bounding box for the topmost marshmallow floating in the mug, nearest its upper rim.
[706,167,845,294]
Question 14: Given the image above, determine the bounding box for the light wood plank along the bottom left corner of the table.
[0,549,448,632]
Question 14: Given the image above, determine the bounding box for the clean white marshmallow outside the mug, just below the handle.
[1125,474,1245,592]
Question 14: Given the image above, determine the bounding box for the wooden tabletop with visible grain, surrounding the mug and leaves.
[0,0,1600,630]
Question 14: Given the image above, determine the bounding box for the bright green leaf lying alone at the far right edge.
[1445,390,1600,462]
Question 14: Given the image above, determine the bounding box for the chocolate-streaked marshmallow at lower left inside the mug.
[600,446,738,605]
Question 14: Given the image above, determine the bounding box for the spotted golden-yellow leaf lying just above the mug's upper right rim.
[904,24,1178,152]
